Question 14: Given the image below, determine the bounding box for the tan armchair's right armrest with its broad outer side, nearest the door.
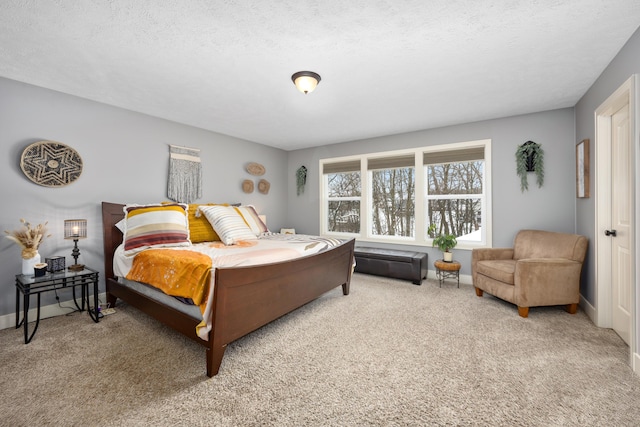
[514,258,582,307]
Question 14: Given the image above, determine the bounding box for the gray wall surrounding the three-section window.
[287,108,575,274]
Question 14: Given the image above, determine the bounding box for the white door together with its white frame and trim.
[596,75,637,358]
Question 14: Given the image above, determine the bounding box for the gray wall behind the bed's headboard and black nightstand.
[0,78,287,315]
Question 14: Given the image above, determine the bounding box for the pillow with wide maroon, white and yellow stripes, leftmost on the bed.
[124,203,191,255]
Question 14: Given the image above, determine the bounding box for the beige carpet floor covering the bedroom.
[0,274,640,426]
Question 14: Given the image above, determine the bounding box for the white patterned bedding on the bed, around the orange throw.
[113,233,342,340]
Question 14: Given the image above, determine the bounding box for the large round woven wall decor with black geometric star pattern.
[20,141,82,187]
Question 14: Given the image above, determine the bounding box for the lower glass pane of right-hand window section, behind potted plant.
[427,198,482,241]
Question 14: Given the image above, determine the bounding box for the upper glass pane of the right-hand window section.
[426,160,484,196]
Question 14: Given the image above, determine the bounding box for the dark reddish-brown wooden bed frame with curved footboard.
[102,202,355,377]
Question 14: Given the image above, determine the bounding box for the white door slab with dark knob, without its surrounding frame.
[611,103,633,345]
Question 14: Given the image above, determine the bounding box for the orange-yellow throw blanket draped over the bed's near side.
[127,249,212,314]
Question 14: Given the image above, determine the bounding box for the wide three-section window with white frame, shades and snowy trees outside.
[320,140,491,249]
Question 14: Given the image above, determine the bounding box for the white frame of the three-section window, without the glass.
[319,139,493,249]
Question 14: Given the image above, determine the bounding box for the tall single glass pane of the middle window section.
[370,167,415,237]
